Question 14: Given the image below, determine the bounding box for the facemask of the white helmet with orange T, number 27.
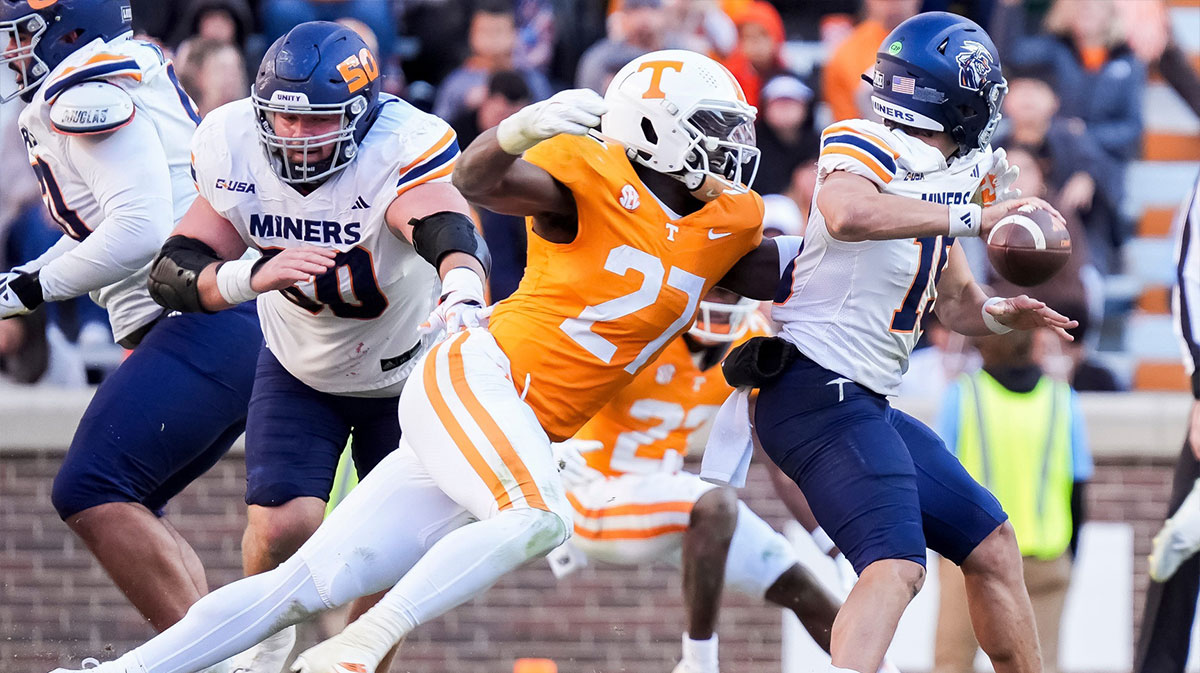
[678,102,760,200]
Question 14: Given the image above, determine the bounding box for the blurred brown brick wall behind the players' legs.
[0,453,1171,673]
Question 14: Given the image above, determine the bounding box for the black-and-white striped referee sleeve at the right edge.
[1172,179,1200,399]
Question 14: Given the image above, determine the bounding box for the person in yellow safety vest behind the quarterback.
[934,331,1092,673]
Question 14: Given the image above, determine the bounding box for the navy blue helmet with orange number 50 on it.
[251,22,382,185]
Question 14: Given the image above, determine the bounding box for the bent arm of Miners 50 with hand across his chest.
[150,191,337,312]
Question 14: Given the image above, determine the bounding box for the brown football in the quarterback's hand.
[988,205,1070,287]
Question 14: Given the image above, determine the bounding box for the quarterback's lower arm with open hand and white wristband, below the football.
[937,241,1079,341]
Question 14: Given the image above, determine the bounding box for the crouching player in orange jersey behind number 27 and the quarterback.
[551,288,839,673]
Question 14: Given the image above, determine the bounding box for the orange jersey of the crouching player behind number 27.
[575,313,770,476]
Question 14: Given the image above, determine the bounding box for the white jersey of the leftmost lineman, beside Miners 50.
[19,36,200,339]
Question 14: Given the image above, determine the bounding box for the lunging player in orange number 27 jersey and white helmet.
[44,50,796,673]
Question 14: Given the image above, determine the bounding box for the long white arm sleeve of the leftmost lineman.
[41,115,174,301]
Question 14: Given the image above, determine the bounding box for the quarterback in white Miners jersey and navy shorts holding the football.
[755,12,1074,673]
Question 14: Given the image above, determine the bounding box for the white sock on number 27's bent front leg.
[344,509,565,657]
